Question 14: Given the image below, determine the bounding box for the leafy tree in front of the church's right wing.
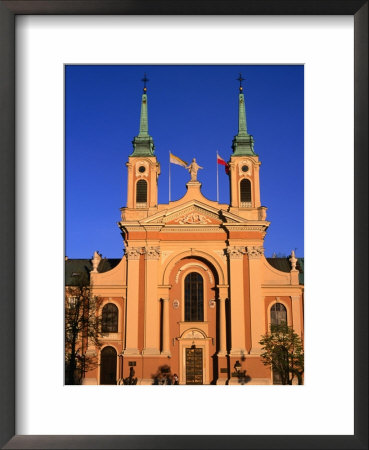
[259,322,304,384]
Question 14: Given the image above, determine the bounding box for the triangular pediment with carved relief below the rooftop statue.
[140,200,247,226]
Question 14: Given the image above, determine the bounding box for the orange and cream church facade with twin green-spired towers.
[66,79,304,384]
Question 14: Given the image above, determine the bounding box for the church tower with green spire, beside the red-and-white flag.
[229,74,261,217]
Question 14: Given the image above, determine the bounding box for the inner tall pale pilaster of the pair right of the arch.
[227,246,246,356]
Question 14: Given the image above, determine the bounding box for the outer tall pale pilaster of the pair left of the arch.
[124,247,142,355]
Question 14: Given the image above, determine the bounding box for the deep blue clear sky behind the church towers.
[65,65,304,258]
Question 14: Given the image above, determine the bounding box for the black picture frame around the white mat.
[0,0,368,449]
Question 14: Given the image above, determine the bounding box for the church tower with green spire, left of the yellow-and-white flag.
[125,74,160,218]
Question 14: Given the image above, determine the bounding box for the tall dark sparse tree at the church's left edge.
[65,273,102,384]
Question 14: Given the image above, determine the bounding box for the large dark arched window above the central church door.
[185,272,204,322]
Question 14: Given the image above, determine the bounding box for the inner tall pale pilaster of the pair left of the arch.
[142,247,160,355]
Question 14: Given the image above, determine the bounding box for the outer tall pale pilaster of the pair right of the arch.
[247,246,265,354]
